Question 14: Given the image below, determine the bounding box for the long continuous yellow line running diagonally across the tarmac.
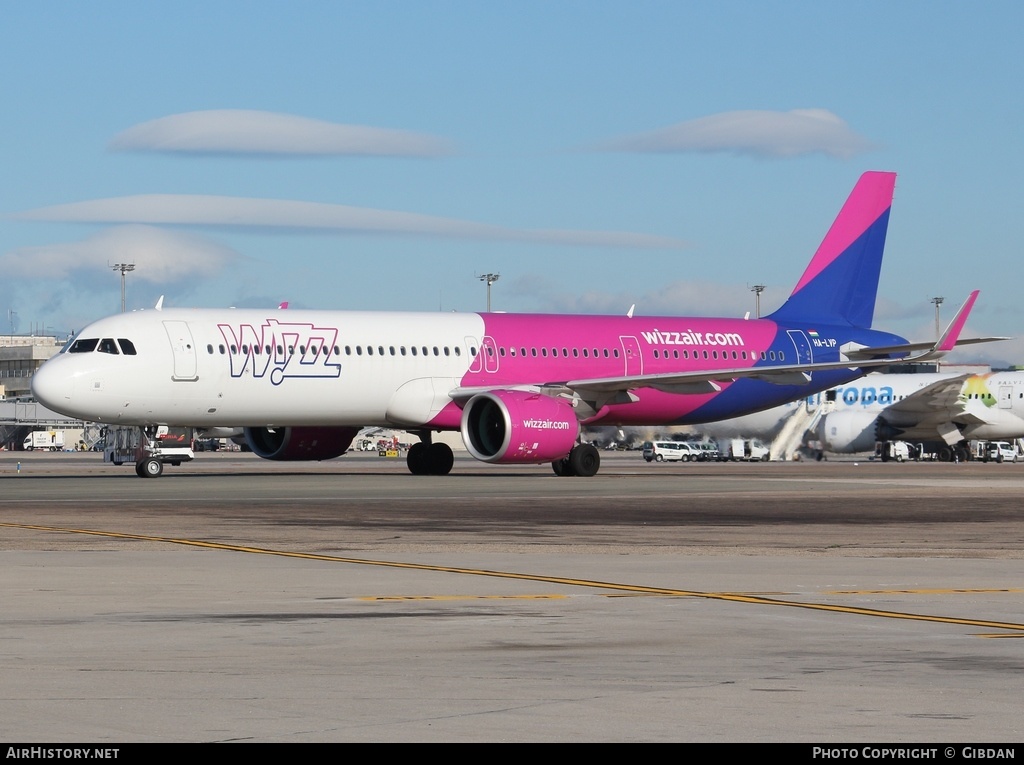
[8,522,1024,638]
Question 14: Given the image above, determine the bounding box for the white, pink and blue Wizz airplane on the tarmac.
[32,172,977,476]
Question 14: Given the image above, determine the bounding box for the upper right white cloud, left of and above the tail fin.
[599,109,874,159]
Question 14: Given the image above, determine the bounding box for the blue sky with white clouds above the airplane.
[0,0,1024,366]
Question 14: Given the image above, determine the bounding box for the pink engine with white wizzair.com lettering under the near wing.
[462,390,580,463]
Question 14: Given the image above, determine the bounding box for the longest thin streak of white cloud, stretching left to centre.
[13,195,685,248]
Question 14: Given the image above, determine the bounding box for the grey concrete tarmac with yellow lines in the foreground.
[0,452,1024,746]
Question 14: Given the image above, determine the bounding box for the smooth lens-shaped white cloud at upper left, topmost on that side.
[110,109,452,157]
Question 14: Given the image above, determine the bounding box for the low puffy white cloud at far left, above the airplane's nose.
[0,225,243,284]
